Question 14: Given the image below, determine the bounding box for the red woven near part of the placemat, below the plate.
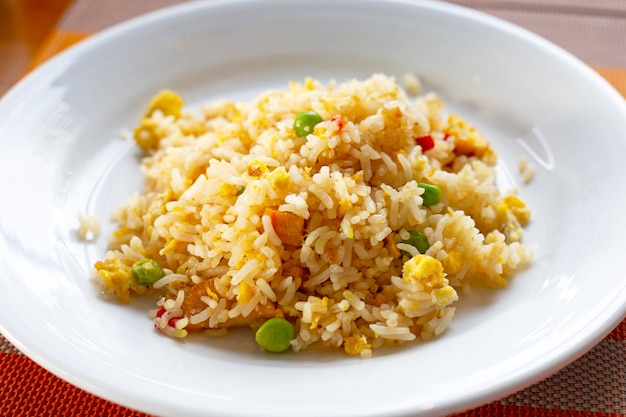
[0,321,626,417]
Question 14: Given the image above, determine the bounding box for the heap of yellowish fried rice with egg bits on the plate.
[95,74,532,357]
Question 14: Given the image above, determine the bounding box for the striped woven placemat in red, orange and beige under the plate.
[0,0,626,417]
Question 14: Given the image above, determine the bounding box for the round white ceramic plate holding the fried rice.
[0,0,626,417]
